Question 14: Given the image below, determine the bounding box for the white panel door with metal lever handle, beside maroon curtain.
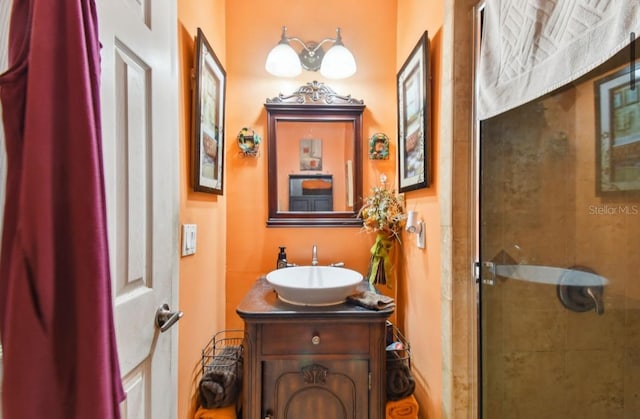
[97,0,179,419]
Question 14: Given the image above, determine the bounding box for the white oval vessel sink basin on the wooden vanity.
[267,266,362,306]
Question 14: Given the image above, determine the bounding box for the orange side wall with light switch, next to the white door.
[177,0,227,419]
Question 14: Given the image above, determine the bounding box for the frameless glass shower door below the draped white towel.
[479,56,640,419]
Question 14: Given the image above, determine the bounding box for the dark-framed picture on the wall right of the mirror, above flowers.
[397,32,431,192]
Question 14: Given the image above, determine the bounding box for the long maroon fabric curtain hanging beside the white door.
[0,0,124,419]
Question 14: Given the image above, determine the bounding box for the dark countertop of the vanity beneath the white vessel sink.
[236,277,393,321]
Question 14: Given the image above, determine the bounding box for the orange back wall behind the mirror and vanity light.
[225,0,396,328]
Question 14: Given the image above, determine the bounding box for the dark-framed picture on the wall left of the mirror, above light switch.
[191,28,226,195]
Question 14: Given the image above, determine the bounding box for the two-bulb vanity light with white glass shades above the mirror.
[264,26,356,79]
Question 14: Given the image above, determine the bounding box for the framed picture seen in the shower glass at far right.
[594,62,640,195]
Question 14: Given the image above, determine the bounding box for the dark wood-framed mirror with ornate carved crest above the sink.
[264,81,365,227]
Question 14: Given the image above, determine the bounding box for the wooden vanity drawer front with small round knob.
[262,323,369,355]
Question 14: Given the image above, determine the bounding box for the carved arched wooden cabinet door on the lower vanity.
[262,359,369,419]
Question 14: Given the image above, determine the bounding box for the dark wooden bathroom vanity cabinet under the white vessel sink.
[237,278,393,419]
